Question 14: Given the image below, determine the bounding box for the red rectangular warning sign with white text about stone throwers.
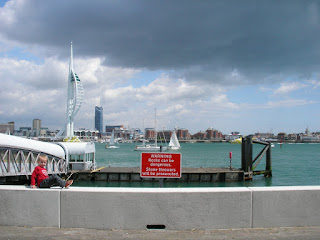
[140,152,181,178]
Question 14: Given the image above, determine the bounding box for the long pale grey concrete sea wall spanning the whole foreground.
[0,186,320,230]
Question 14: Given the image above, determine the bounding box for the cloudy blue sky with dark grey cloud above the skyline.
[0,0,320,134]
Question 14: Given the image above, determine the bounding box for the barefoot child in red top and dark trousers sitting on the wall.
[31,155,73,188]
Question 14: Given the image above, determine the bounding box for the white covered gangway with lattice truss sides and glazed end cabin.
[0,134,95,182]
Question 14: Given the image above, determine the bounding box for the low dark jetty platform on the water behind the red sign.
[72,167,245,182]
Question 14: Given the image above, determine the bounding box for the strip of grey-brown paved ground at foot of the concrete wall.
[0,226,320,240]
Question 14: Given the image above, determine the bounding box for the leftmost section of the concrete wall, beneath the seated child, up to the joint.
[0,186,61,227]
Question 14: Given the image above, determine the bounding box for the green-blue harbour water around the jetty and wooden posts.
[74,143,320,187]
